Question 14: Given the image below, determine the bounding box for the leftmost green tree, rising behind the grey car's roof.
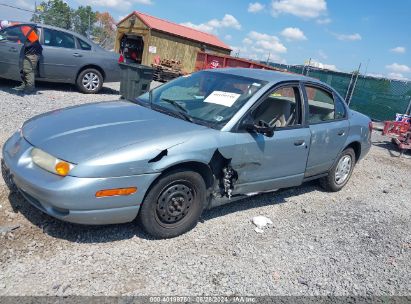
[31,0,73,29]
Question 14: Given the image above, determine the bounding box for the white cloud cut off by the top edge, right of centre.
[271,0,327,18]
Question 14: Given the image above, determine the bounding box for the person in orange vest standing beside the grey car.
[14,25,43,94]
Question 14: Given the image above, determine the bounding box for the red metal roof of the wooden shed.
[118,11,231,51]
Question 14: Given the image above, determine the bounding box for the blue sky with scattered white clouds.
[0,0,411,80]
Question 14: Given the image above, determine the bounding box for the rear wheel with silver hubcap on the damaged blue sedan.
[320,148,356,192]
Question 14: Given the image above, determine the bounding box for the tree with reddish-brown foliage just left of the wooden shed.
[93,12,116,49]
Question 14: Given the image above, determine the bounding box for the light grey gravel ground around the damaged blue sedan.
[0,81,411,296]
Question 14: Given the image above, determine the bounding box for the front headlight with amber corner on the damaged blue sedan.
[31,148,74,176]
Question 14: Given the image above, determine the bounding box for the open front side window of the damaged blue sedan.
[252,86,301,128]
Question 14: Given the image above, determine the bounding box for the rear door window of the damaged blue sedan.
[305,86,335,123]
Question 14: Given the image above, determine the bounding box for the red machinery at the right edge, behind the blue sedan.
[382,115,411,155]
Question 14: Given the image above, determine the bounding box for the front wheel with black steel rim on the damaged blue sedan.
[137,170,206,239]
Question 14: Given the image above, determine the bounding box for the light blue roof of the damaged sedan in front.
[208,68,325,85]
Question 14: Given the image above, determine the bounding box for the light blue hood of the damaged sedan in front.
[23,101,207,164]
